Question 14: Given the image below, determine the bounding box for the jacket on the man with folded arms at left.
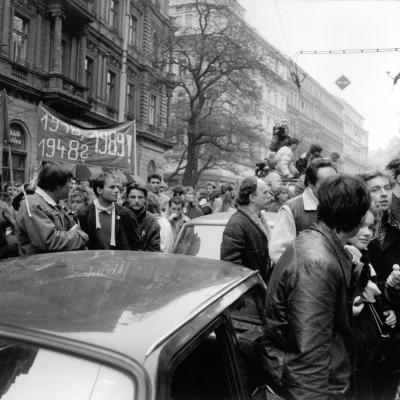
[17,193,88,255]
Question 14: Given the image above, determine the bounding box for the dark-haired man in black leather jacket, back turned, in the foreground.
[262,175,370,400]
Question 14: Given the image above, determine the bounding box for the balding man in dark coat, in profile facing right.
[221,176,272,281]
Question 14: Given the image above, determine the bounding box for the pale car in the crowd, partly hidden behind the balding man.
[173,212,276,260]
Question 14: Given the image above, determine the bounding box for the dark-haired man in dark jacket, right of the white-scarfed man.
[126,183,161,251]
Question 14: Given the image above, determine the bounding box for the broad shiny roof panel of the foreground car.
[0,250,255,362]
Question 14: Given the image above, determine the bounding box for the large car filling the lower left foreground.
[0,250,265,400]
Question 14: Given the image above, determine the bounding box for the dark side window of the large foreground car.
[170,325,241,400]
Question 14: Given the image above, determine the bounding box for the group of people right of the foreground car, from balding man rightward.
[221,152,400,400]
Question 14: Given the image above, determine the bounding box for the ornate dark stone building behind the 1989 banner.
[0,0,171,182]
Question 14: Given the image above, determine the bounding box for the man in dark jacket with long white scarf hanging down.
[78,172,140,250]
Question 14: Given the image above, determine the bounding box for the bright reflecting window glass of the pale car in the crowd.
[175,224,225,260]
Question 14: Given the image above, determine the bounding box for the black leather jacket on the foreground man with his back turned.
[262,223,352,400]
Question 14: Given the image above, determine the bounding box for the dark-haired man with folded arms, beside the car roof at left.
[17,162,88,255]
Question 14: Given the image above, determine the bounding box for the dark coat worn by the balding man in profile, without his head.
[221,209,270,281]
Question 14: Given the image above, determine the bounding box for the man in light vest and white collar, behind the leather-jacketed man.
[269,158,336,264]
